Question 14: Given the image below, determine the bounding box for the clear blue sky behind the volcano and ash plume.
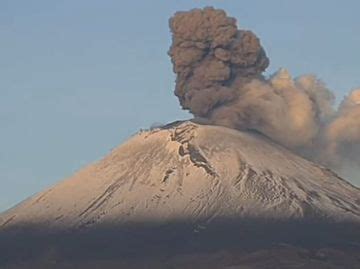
[0,0,360,211]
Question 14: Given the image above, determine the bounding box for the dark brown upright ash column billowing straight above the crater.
[169,8,269,117]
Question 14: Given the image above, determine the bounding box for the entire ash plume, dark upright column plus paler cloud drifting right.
[169,7,360,177]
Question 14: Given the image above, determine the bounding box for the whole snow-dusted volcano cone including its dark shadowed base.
[0,121,360,268]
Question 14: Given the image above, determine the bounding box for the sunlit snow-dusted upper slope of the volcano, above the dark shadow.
[0,122,360,230]
